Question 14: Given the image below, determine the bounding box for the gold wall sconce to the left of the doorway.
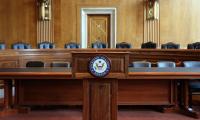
[38,0,51,20]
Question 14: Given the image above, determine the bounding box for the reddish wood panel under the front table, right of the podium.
[118,80,174,105]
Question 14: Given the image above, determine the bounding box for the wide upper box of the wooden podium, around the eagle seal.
[72,51,129,78]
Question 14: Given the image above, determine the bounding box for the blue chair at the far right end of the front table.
[183,61,200,108]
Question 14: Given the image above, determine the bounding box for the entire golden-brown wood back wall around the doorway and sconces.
[0,0,200,48]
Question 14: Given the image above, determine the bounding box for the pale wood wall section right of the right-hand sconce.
[160,0,200,48]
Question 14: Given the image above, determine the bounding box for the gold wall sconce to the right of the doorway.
[146,0,159,20]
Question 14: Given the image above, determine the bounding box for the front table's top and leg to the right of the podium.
[127,67,200,118]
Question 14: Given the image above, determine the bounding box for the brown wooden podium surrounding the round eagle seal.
[72,52,129,120]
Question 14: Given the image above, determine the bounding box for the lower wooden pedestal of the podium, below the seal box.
[83,79,118,120]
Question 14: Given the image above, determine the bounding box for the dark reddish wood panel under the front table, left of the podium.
[18,80,83,105]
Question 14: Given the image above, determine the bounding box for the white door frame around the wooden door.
[81,7,117,48]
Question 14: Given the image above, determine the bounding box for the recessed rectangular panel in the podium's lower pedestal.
[90,82,112,120]
